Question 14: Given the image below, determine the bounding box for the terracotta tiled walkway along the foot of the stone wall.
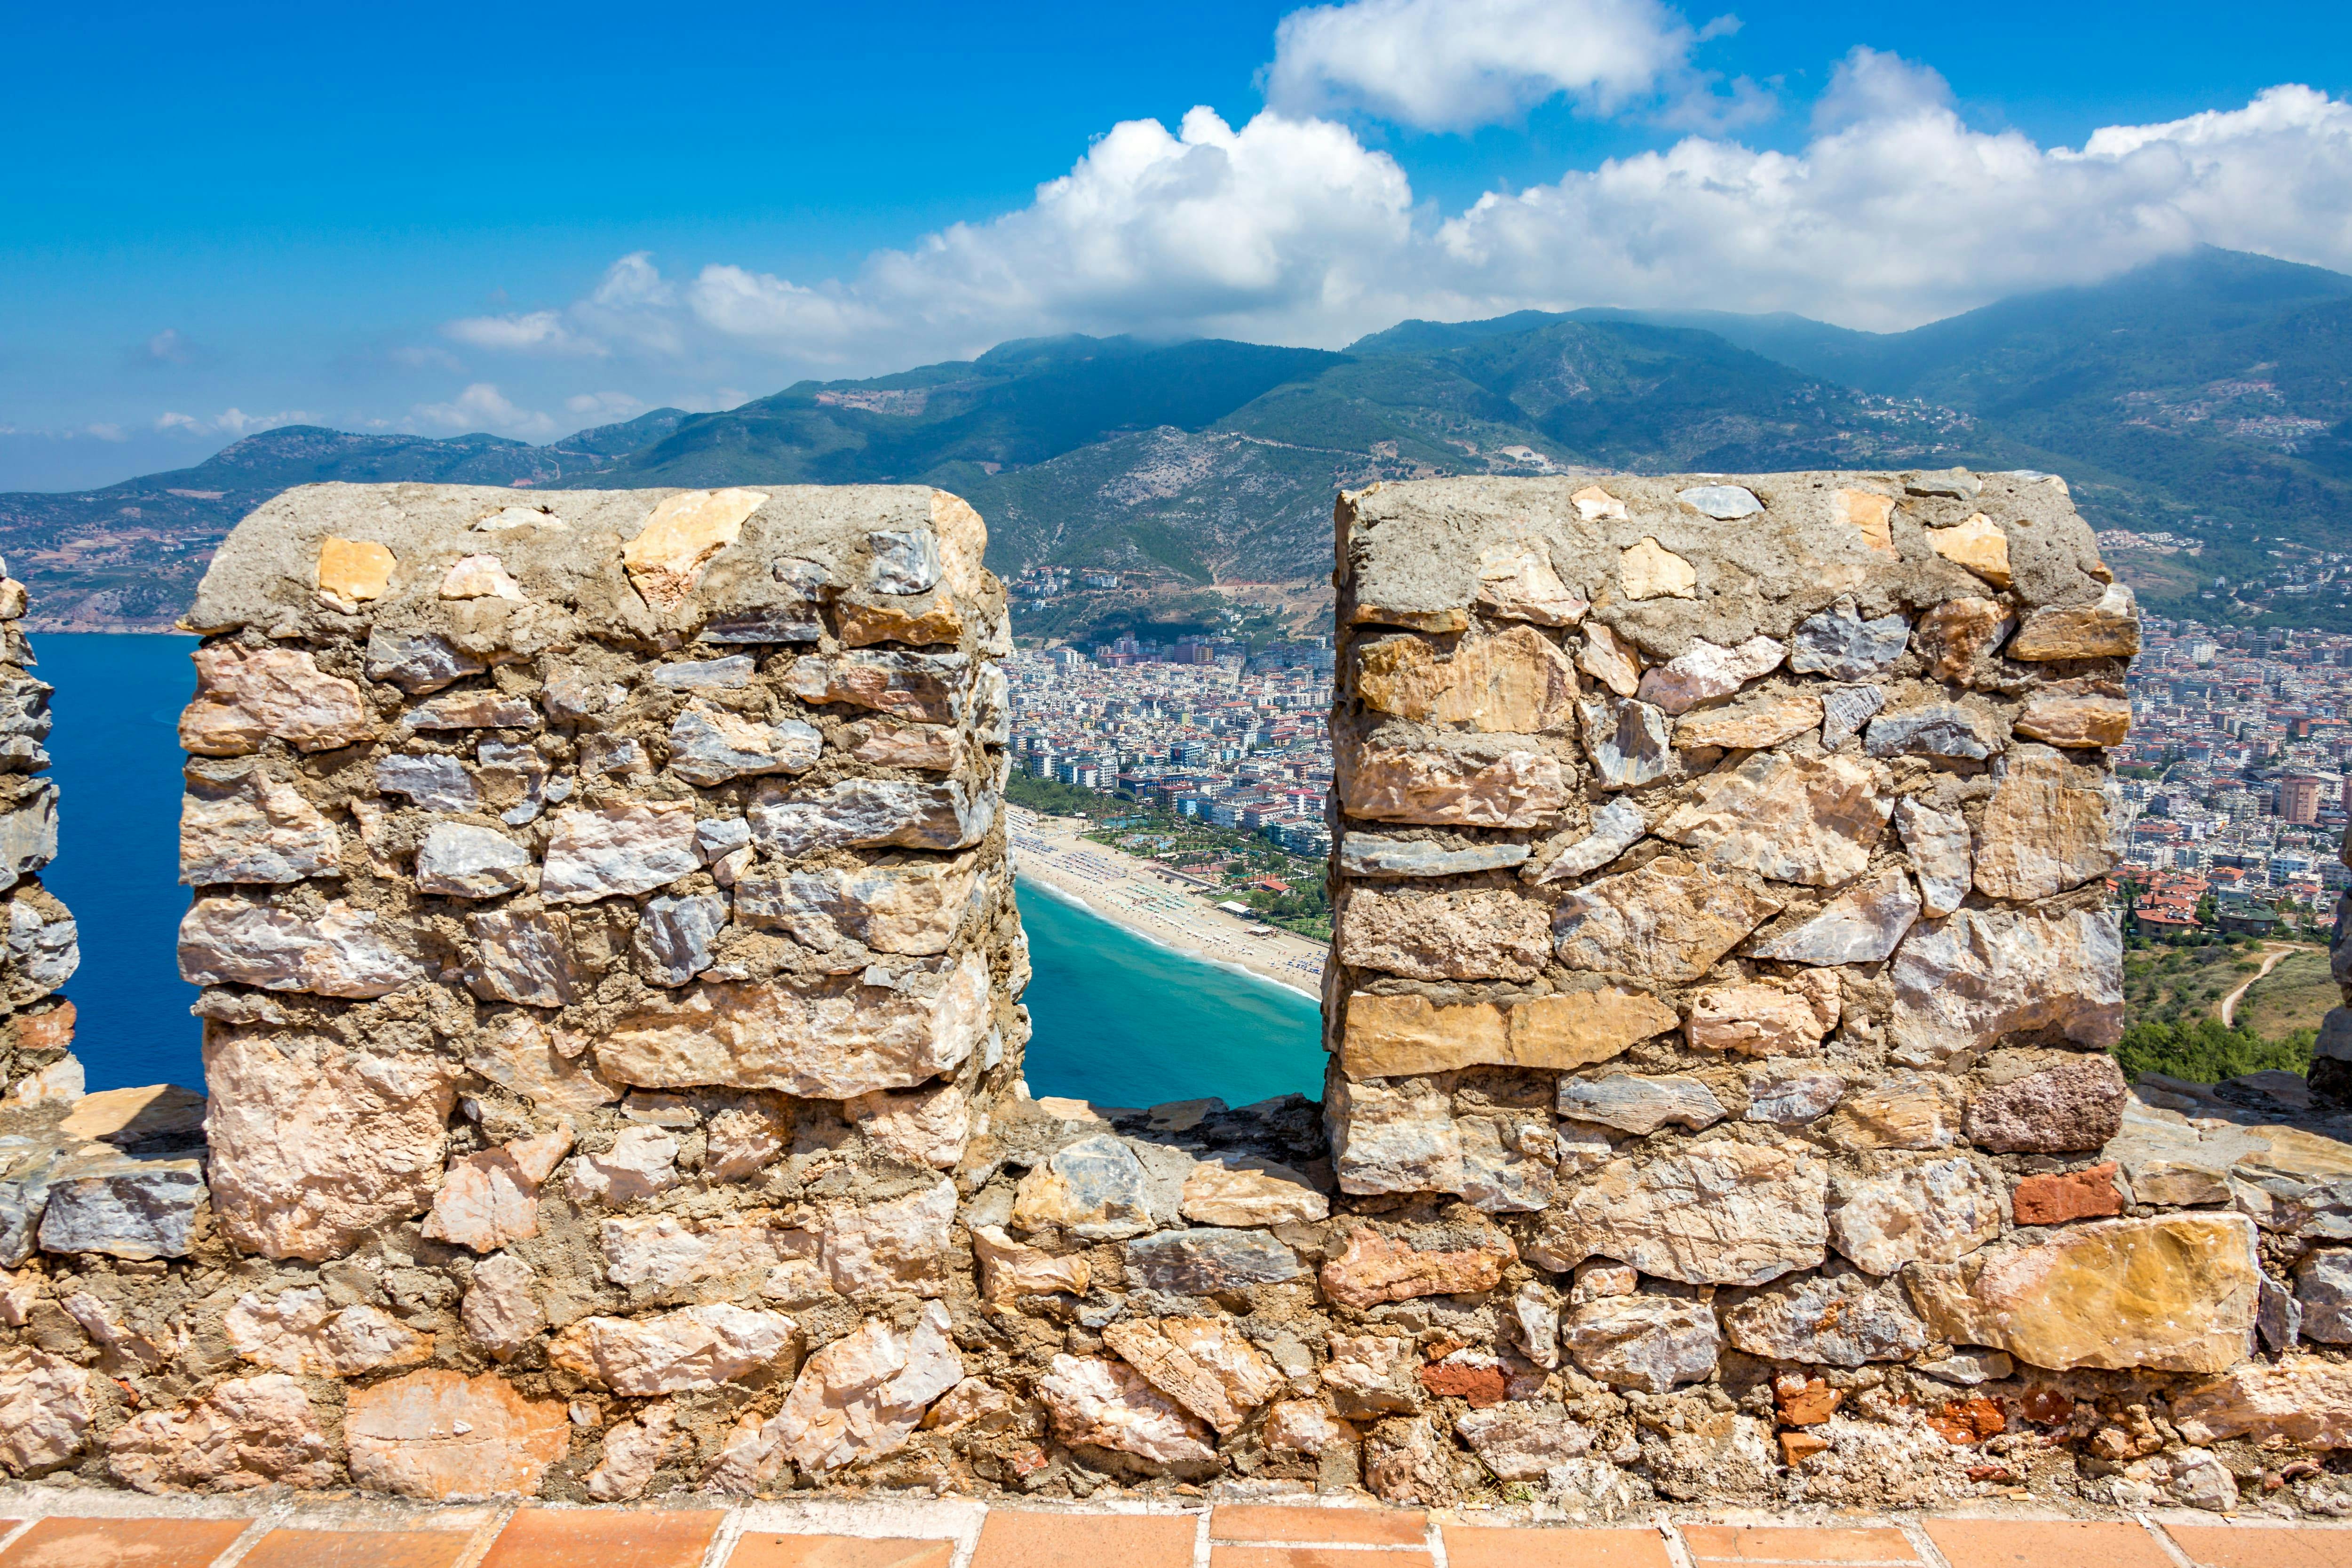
[0,1495,2352,1568]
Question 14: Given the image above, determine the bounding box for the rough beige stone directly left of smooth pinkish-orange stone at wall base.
[106,1373,341,1493]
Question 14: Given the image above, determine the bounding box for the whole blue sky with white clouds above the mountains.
[0,0,2352,489]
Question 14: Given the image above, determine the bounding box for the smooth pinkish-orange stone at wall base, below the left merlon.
[343,1368,572,1502]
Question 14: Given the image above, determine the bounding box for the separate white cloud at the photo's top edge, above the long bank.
[1265,0,1769,132]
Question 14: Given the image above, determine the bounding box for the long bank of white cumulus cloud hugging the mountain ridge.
[435,48,2352,376]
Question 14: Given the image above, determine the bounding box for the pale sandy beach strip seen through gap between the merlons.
[1007,806,1324,1002]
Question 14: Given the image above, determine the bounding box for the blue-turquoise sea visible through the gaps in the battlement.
[33,632,1324,1105]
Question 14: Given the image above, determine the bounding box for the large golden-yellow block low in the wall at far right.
[1907,1213,2263,1373]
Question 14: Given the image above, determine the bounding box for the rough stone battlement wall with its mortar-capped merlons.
[0,472,2352,1540]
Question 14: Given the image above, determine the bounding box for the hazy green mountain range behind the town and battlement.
[0,249,2352,635]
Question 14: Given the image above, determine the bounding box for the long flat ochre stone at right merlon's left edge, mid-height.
[1341,985,1677,1079]
